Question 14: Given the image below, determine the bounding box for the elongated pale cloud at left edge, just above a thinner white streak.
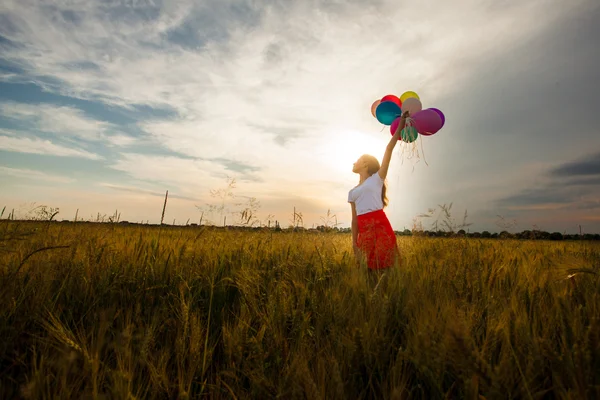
[0,101,135,146]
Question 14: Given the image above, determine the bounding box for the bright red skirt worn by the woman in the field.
[356,210,398,269]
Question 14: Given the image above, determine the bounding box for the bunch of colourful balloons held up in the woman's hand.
[371,91,446,143]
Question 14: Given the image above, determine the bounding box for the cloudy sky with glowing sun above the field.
[0,0,600,233]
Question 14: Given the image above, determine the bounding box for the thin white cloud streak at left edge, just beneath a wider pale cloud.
[0,134,102,160]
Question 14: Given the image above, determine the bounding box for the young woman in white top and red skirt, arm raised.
[348,112,409,271]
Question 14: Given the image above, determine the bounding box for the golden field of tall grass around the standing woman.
[0,221,600,400]
